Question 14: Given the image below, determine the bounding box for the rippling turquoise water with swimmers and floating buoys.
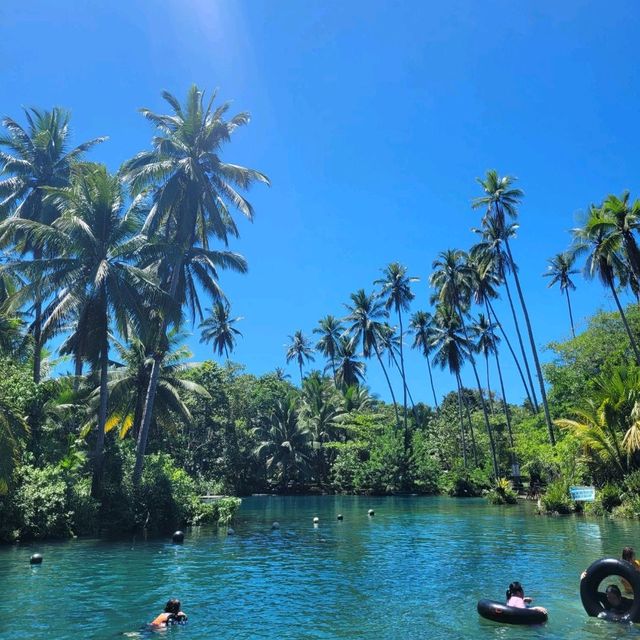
[0,496,640,640]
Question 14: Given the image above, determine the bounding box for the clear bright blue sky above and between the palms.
[0,0,640,400]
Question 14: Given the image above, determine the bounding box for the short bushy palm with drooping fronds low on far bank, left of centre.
[254,394,311,488]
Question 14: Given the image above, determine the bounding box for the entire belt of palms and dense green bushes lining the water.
[0,87,640,540]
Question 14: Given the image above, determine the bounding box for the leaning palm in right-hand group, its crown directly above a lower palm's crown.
[429,249,500,478]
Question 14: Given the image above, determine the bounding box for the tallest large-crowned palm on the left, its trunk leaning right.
[123,85,269,484]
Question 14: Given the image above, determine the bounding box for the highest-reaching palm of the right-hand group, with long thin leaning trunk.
[473,170,556,445]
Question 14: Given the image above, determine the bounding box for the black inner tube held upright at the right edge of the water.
[580,558,640,622]
